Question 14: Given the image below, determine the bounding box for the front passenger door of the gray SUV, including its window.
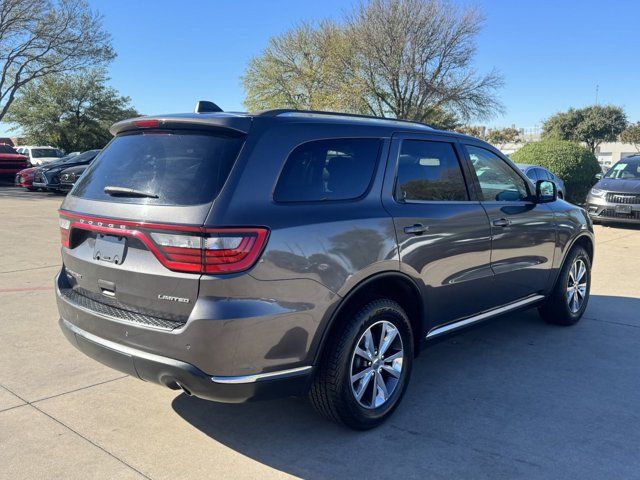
[465,143,556,303]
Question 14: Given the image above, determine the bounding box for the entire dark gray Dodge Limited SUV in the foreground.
[56,104,593,429]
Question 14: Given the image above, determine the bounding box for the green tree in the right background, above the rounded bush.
[542,105,627,153]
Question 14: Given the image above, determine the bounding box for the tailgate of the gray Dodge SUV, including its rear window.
[61,130,244,320]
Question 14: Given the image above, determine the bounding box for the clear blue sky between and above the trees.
[0,0,640,136]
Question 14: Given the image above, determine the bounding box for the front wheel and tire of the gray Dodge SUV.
[539,246,591,326]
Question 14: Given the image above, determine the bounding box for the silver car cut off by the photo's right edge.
[587,155,640,223]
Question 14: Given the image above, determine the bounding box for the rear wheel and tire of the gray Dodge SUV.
[309,299,413,430]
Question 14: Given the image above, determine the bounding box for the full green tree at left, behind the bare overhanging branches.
[7,70,138,152]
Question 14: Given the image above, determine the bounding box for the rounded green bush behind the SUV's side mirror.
[511,140,600,203]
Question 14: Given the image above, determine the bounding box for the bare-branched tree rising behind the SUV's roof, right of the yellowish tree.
[348,0,503,121]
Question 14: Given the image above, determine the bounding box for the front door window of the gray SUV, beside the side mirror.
[467,145,529,202]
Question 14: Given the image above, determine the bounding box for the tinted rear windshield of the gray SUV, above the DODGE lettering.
[72,131,244,205]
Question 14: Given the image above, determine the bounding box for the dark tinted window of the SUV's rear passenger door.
[396,140,468,200]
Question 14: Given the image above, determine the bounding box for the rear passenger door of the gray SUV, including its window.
[383,134,497,326]
